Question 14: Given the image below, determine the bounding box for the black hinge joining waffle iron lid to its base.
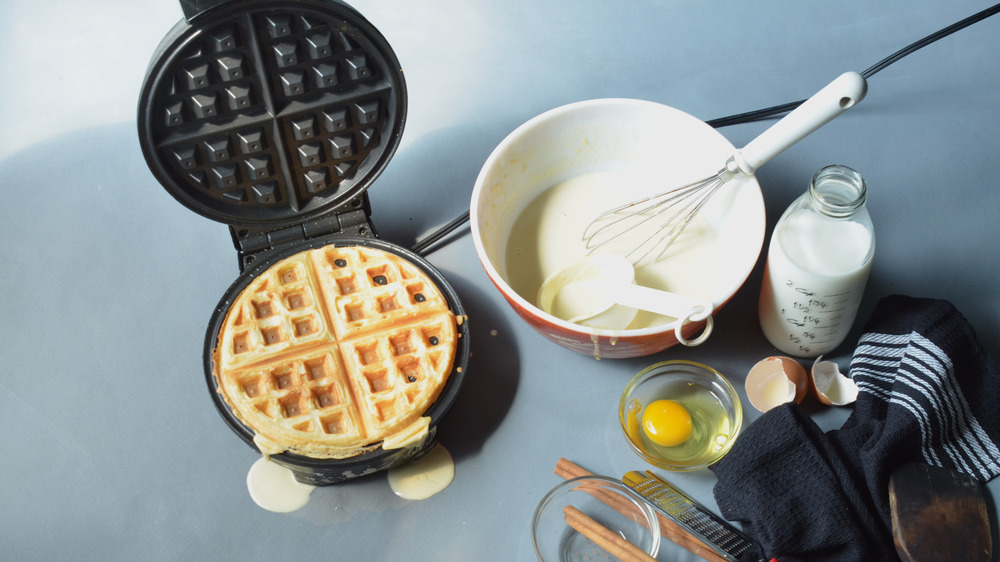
[229,208,376,273]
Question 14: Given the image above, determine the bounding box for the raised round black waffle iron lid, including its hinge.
[138,0,406,265]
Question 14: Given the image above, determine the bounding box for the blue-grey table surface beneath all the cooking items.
[0,0,1000,560]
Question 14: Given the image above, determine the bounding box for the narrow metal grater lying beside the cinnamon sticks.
[622,470,756,562]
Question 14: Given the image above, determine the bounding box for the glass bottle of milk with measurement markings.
[758,166,875,357]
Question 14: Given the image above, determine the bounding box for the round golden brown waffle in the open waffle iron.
[213,246,458,458]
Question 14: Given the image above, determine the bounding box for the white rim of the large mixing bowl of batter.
[469,98,767,339]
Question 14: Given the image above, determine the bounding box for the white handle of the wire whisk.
[732,72,868,175]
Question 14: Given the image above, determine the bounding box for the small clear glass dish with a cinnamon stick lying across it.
[531,476,660,562]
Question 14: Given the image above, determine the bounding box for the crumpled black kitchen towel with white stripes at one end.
[711,295,1000,562]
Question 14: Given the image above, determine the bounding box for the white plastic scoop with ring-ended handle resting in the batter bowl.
[537,254,712,345]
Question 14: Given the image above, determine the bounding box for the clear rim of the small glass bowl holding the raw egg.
[618,359,743,472]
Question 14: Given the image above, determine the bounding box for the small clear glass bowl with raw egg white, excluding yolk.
[618,361,743,472]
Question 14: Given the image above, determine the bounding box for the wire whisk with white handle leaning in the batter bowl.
[583,72,868,263]
